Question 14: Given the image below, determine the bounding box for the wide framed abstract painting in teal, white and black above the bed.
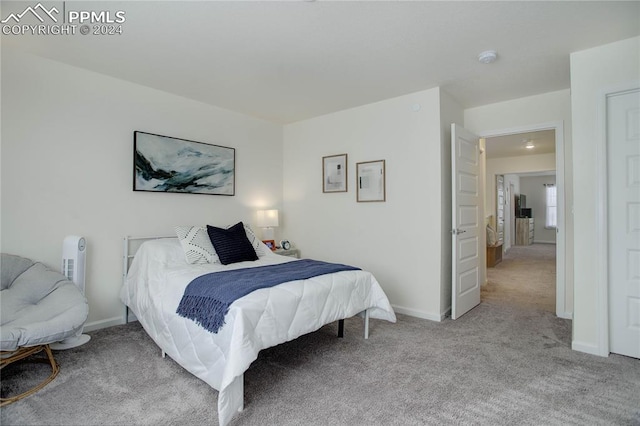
[133,131,236,195]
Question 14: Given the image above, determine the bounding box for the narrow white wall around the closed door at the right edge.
[571,37,640,355]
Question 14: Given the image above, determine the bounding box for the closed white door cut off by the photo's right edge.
[607,90,640,358]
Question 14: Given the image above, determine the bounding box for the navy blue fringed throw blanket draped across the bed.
[176,259,360,333]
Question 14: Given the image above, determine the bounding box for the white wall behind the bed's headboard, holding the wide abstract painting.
[1,46,282,327]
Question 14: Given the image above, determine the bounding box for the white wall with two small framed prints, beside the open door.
[283,89,450,320]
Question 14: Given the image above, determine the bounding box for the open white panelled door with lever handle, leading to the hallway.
[451,124,485,319]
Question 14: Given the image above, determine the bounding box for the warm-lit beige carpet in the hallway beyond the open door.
[481,244,556,313]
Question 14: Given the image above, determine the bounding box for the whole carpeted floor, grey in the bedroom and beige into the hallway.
[5,246,640,426]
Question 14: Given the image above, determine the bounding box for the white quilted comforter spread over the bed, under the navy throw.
[120,238,396,425]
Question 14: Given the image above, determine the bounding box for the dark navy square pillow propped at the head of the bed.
[207,222,258,265]
